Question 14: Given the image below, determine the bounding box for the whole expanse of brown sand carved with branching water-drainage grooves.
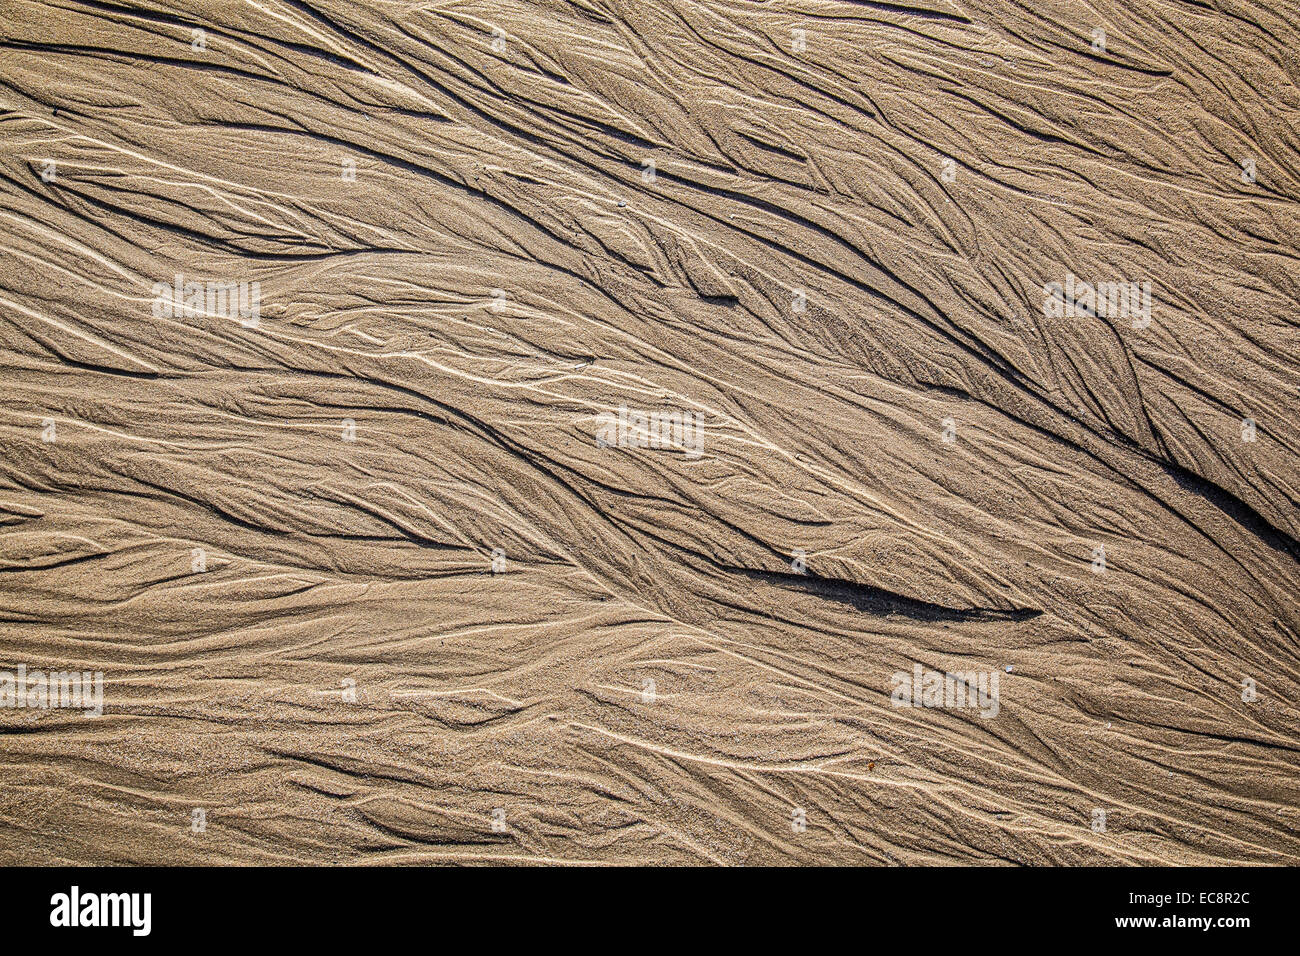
[0,0,1300,864]
